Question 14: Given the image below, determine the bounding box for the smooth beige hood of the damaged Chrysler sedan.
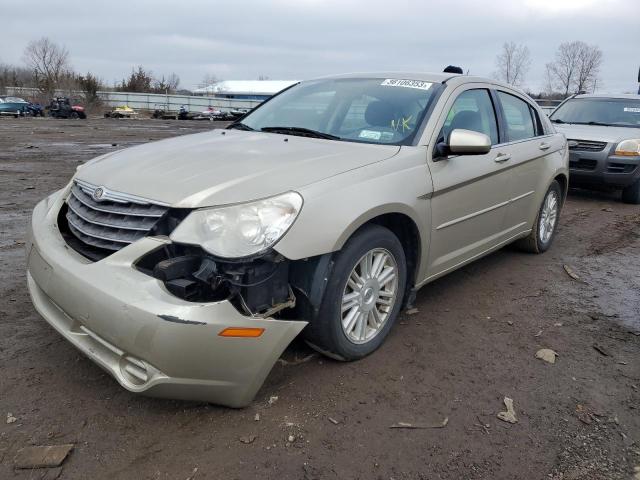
[76,130,400,208]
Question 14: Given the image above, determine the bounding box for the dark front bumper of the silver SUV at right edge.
[569,147,640,188]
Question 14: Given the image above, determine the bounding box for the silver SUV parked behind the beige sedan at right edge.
[550,94,640,204]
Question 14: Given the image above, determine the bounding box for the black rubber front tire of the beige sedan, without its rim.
[304,225,407,361]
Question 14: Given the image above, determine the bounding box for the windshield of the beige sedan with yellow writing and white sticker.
[240,78,437,145]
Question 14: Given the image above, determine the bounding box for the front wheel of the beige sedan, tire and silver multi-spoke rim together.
[304,225,407,361]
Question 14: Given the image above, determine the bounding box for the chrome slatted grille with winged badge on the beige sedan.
[66,180,169,251]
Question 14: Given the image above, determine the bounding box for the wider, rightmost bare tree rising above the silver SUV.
[547,41,602,96]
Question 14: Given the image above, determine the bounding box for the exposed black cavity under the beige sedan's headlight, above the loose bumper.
[135,244,296,318]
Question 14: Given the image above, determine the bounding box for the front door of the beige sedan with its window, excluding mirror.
[427,84,511,277]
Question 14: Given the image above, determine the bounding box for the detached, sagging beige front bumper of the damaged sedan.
[27,195,307,407]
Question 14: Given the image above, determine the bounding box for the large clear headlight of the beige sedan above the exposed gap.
[171,192,302,258]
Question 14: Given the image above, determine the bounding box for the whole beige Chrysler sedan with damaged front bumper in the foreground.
[27,74,569,407]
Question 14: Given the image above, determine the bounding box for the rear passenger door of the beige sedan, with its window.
[495,88,563,235]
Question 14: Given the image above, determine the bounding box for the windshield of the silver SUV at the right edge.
[550,97,640,128]
